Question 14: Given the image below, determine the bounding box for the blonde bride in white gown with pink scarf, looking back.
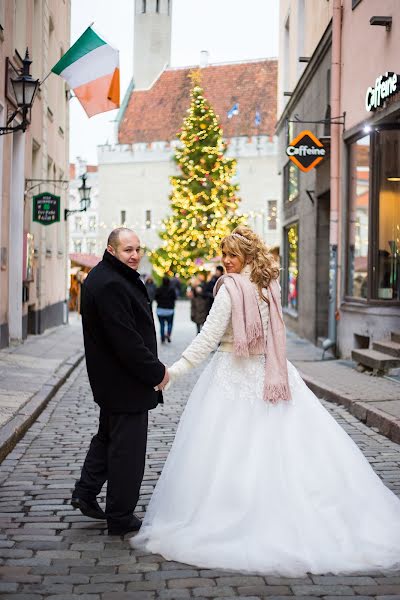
[130,226,400,577]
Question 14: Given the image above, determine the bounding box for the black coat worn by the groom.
[82,250,165,412]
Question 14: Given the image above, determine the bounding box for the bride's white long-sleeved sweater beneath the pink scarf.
[167,268,269,387]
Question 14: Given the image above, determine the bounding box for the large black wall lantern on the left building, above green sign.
[0,48,39,135]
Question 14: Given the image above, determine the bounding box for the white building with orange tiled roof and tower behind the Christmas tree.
[98,0,280,272]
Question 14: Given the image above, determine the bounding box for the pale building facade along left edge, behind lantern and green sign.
[0,0,70,347]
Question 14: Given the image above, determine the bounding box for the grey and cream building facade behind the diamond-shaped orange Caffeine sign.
[277,0,332,342]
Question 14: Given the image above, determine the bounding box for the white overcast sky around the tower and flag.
[70,0,279,164]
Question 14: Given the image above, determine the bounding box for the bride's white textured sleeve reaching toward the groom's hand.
[168,285,232,380]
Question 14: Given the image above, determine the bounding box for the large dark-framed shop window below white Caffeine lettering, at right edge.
[347,126,400,302]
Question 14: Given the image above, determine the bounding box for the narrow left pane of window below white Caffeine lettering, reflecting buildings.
[347,136,370,298]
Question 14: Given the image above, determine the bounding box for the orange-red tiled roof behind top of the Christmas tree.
[118,59,278,144]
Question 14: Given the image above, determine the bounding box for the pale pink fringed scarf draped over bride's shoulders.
[214,273,291,404]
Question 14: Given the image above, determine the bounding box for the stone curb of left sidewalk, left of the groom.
[0,352,85,463]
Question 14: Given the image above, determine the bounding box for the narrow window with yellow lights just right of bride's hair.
[282,223,299,313]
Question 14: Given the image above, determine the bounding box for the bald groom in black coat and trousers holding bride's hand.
[71,227,168,535]
